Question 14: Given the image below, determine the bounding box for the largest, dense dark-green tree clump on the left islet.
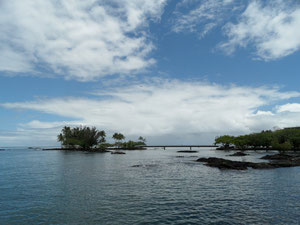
[57,126,106,150]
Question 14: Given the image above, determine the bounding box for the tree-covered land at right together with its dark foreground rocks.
[197,127,300,170]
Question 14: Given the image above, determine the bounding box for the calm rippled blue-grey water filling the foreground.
[0,149,300,225]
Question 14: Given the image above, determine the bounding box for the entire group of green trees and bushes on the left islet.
[57,126,146,151]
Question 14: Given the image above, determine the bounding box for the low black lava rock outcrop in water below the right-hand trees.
[196,154,300,170]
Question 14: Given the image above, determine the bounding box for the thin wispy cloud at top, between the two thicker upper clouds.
[172,0,235,37]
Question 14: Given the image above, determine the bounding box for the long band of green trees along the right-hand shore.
[215,127,300,151]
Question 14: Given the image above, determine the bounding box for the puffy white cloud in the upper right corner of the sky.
[220,0,300,60]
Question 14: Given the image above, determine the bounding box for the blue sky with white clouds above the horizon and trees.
[0,0,300,146]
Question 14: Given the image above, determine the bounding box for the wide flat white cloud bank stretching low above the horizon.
[1,80,300,146]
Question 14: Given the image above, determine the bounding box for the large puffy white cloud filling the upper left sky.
[0,0,166,81]
